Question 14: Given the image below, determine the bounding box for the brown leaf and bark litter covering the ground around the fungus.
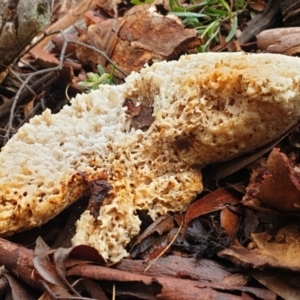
[0,1,300,299]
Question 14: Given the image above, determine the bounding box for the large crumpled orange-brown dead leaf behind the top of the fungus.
[76,5,201,77]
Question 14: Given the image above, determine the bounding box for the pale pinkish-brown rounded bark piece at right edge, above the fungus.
[256,27,300,55]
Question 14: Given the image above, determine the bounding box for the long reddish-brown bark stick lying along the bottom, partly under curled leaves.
[0,239,276,300]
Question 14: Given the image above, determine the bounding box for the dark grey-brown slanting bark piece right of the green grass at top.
[238,0,280,44]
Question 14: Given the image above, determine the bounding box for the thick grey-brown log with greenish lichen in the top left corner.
[0,0,52,82]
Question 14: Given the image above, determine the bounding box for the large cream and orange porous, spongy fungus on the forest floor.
[0,53,300,261]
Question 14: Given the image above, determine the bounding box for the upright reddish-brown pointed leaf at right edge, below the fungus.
[258,148,300,211]
